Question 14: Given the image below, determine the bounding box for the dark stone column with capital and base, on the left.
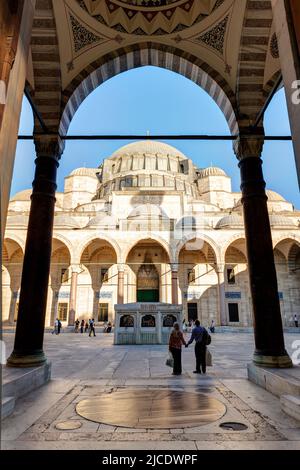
[7,138,62,367]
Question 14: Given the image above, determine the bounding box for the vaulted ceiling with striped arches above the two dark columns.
[28,0,280,133]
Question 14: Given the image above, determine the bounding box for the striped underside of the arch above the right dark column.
[236,0,273,126]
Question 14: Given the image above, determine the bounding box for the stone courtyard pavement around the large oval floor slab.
[2,333,300,450]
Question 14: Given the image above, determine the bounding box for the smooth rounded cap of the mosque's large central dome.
[110,140,187,159]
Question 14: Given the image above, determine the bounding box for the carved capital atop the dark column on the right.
[233,127,265,160]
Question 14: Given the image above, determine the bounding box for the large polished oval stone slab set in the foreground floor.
[76,389,226,429]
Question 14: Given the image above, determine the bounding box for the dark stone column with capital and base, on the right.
[235,135,292,367]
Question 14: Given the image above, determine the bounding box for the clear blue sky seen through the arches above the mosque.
[11,67,300,208]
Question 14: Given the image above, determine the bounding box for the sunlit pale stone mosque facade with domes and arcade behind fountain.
[2,141,300,326]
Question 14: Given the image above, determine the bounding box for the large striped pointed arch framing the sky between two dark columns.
[60,43,238,135]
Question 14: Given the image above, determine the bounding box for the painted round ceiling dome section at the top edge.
[77,0,225,36]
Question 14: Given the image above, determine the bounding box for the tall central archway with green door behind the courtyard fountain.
[126,239,171,302]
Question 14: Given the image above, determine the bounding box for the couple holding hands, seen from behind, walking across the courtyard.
[169,320,214,375]
